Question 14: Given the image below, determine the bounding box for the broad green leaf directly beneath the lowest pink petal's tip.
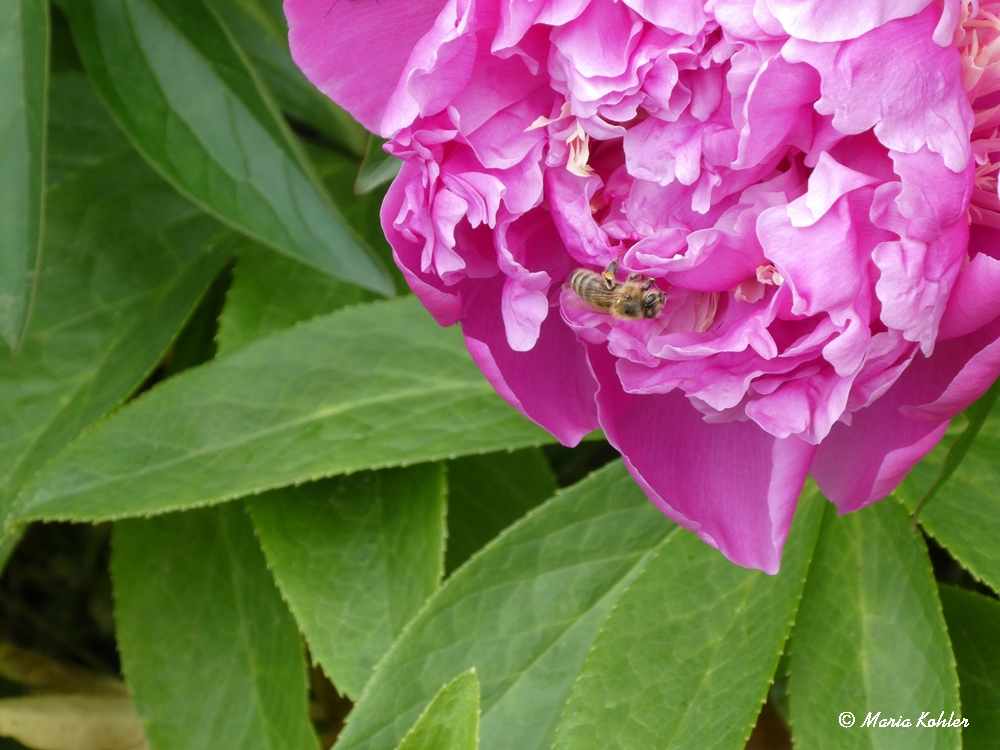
[553,484,823,750]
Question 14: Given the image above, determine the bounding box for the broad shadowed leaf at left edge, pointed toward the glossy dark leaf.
[0,75,232,540]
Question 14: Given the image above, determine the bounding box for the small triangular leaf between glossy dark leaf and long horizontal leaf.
[218,243,376,354]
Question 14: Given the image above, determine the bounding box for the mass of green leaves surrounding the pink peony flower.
[0,0,1000,750]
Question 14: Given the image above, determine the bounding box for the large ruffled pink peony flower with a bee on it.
[285,0,1000,573]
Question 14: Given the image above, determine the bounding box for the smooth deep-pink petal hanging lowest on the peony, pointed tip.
[588,346,816,574]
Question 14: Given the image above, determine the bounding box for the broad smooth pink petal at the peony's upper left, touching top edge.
[285,0,445,131]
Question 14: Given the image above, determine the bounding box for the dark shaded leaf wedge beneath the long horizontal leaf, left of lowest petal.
[445,448,556,575]
